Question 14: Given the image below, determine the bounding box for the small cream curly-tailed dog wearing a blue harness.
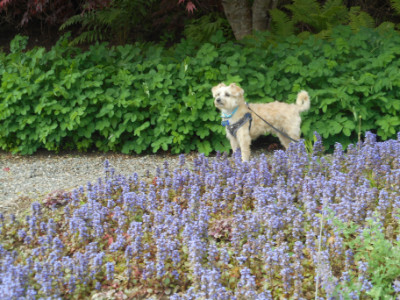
[211,83,310,161]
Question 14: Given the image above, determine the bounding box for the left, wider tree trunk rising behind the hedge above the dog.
[222,0,252,40]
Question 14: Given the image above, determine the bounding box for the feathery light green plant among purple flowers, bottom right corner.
[330,208,400,299]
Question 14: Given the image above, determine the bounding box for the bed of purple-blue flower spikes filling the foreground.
[0,133,400,299]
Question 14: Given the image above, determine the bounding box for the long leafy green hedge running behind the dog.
[0,26,400,154]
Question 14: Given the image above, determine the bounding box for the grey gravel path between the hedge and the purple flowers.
[0,152,195,215]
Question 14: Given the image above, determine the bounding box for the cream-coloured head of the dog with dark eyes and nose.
[211,83,244,111]
